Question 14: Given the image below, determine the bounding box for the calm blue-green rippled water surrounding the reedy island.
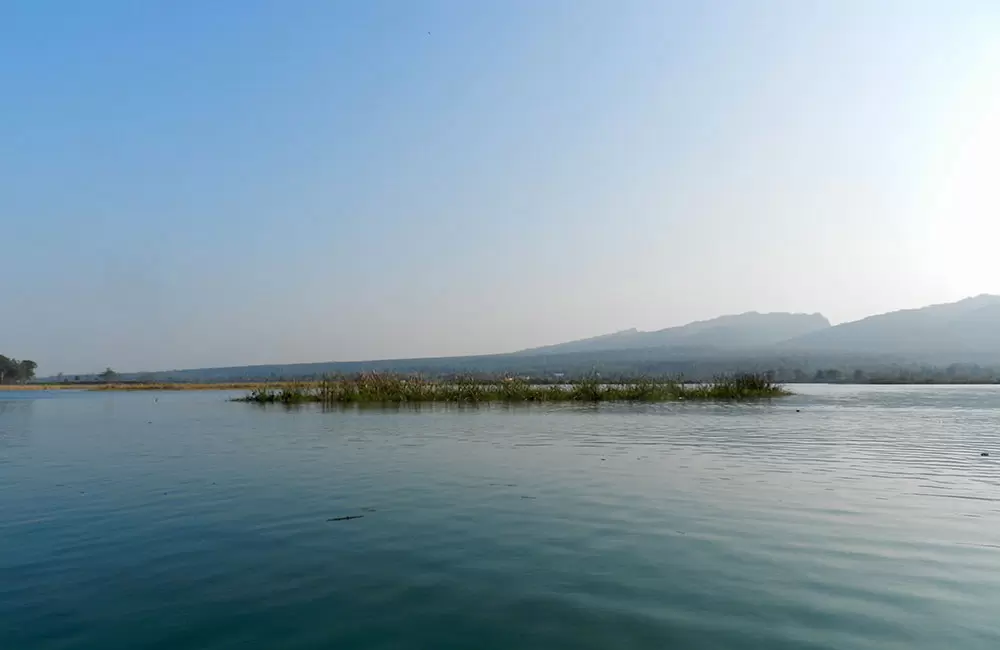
[0,386,1000,650]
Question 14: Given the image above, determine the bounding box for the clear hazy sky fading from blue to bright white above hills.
[0,0,1000,374]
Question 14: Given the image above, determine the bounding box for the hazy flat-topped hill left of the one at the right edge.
[518,311,830,355]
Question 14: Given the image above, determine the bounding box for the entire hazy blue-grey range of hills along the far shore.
[45,294,1000,381]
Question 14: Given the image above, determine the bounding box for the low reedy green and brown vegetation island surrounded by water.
[236,373,789,404]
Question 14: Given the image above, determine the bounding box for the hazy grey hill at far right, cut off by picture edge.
[780,294,1000,361]
